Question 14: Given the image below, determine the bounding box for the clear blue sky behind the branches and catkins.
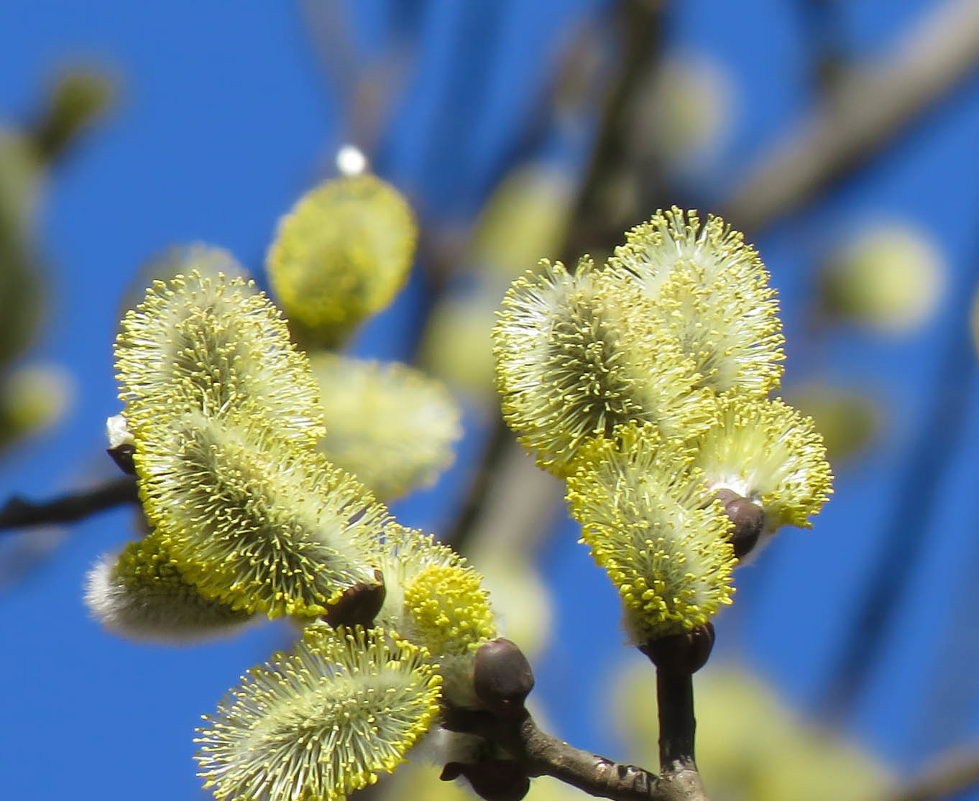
[0,0,979,801]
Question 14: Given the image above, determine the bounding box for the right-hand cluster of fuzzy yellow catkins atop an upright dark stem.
[494,208,830,642]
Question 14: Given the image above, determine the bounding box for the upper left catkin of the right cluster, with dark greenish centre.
[493,261,712,477]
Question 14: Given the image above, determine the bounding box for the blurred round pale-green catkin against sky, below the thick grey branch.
[820,223,946,335]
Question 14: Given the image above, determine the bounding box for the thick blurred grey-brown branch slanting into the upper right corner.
[724,0,979,230]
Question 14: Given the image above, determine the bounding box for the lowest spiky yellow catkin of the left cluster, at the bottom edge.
[196,626,441,801]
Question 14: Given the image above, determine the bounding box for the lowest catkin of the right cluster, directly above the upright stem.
[568,425,736,642]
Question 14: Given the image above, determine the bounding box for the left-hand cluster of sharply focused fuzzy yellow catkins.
[86,273,496,801]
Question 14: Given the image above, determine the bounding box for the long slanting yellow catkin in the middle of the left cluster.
[135,414,388,617]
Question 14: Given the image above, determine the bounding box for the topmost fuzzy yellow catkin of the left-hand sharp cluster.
[116,273,324,445]
